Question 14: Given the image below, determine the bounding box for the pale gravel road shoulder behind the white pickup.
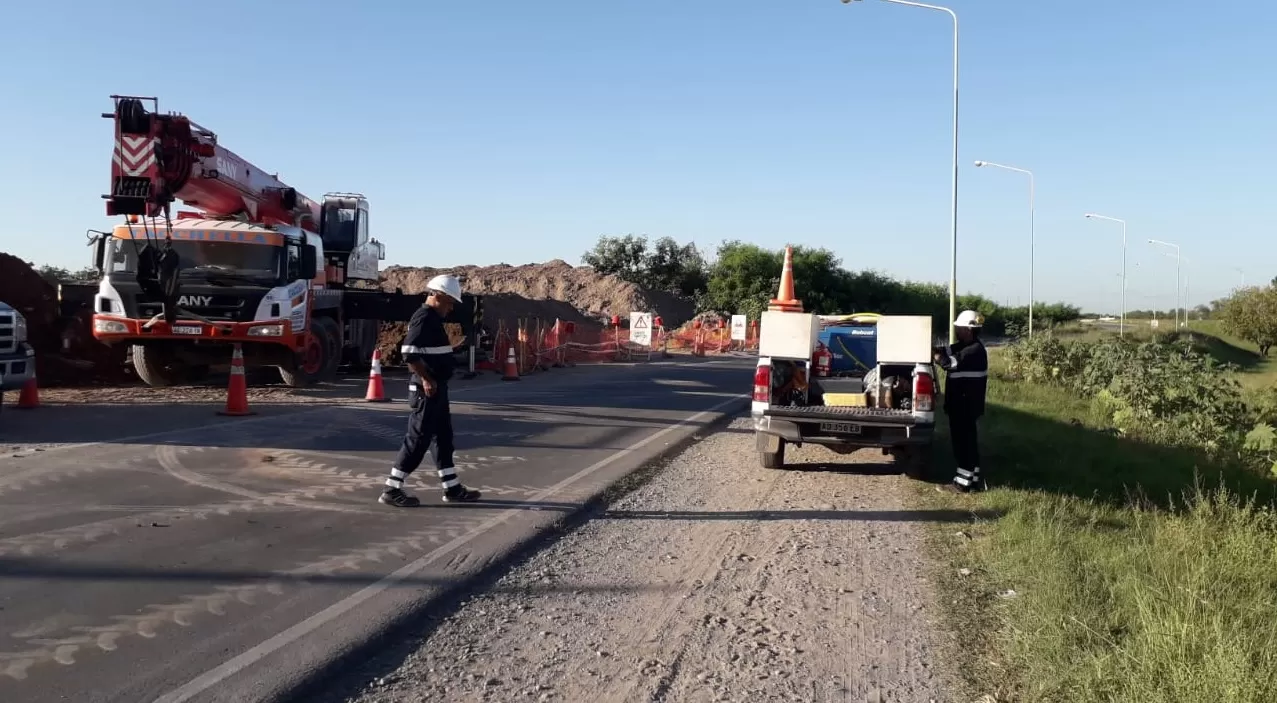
[341,418,953,703]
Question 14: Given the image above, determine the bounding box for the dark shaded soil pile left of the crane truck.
[0,253,130,385]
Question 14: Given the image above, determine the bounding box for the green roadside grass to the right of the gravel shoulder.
[923,365,1277,703]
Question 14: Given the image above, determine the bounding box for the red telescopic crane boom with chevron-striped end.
[102,96,321,232]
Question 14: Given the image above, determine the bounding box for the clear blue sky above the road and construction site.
[0,0,1277,310]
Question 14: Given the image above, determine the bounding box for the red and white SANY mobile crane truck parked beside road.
[83,96,476,387]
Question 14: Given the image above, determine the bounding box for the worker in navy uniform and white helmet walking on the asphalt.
[379,276,479,508]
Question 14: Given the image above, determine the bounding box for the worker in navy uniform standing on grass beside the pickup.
[935,310,988,492]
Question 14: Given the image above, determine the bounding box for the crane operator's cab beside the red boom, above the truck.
[319,193,386,285]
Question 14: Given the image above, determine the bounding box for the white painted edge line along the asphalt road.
[155,394,747,703]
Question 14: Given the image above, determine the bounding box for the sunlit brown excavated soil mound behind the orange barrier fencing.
[378,259,696,362]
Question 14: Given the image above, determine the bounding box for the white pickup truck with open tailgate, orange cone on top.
[752,311,939,477]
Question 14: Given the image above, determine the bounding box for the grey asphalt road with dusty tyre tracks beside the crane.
[0,360,750,703]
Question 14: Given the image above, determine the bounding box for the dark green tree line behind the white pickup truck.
[581,235,1082,336]
